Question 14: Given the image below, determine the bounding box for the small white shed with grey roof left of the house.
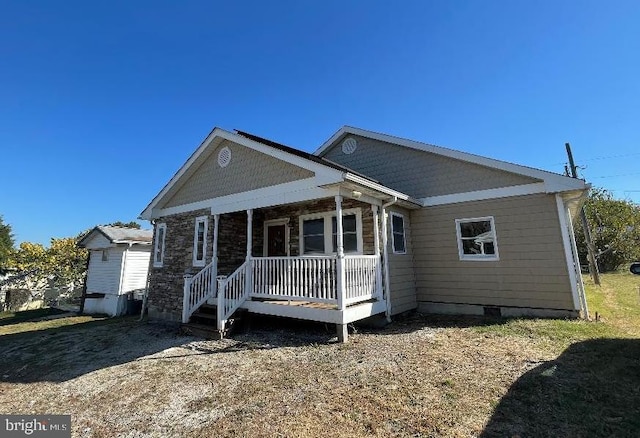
[78,226,153,316]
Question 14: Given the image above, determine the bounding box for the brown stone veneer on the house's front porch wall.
[148,198,374,322]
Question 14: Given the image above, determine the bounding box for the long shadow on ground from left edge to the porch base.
[0,317,335,383]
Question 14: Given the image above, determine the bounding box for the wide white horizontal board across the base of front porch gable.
[152,176,341,219]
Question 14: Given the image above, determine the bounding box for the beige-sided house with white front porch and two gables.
[141,127,588,340]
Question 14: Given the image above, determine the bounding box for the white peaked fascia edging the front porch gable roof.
[139,128,342,220]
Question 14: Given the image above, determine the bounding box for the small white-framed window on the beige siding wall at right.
[456,216,498,260]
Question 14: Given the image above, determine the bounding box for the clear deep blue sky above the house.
[0,0,640,244]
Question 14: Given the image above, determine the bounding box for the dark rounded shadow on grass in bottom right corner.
[481,339,640,438]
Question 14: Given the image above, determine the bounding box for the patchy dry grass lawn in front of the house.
[0,274,640,437]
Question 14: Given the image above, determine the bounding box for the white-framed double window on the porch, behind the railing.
[300,208,362,255]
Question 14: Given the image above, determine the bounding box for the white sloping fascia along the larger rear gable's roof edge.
[314,126,585,191]
